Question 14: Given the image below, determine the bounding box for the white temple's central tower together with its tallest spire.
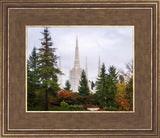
[69,37,82,92]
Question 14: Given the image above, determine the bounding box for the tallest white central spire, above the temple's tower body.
[74,37,80,68]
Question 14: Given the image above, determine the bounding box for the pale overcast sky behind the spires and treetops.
[27,27,134,83]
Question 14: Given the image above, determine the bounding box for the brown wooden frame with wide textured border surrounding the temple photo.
[0,0,160,138]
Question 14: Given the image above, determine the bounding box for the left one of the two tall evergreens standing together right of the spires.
[96,63,107,107]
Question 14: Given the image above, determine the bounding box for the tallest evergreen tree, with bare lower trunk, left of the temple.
[37,28,60,111]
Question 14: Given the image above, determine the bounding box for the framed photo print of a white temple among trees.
[26,26,134,112]
